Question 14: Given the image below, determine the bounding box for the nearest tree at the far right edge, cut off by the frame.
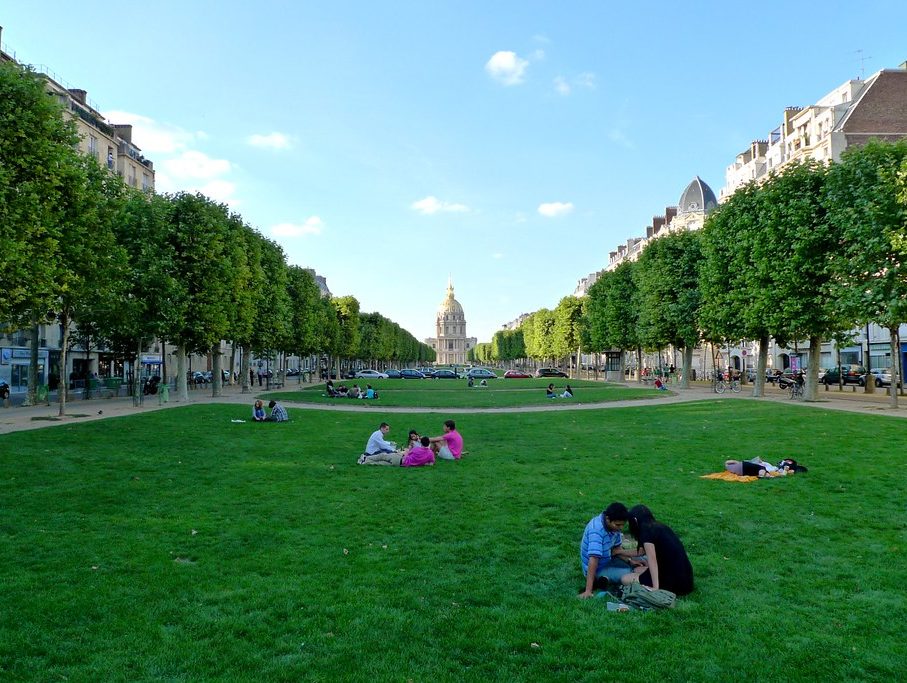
[823,140,907,407]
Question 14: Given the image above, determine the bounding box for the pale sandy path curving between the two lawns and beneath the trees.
[0,381,907,435]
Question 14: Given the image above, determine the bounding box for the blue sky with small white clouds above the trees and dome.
[0,0,907,341]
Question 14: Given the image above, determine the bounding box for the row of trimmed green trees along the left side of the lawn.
[0,63,434,415]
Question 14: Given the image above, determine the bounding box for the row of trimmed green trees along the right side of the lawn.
[475,140,907,405]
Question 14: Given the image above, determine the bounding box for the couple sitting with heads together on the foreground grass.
[579,503,693,598]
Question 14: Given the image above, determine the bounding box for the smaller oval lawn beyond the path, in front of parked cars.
[261,378,666,412]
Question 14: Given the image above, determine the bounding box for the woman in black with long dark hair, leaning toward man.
[621,505,693,595]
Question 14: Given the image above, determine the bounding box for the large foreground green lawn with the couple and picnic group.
[0,400,907,681]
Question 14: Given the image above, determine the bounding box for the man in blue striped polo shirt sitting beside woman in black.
[579,503,639,598]
